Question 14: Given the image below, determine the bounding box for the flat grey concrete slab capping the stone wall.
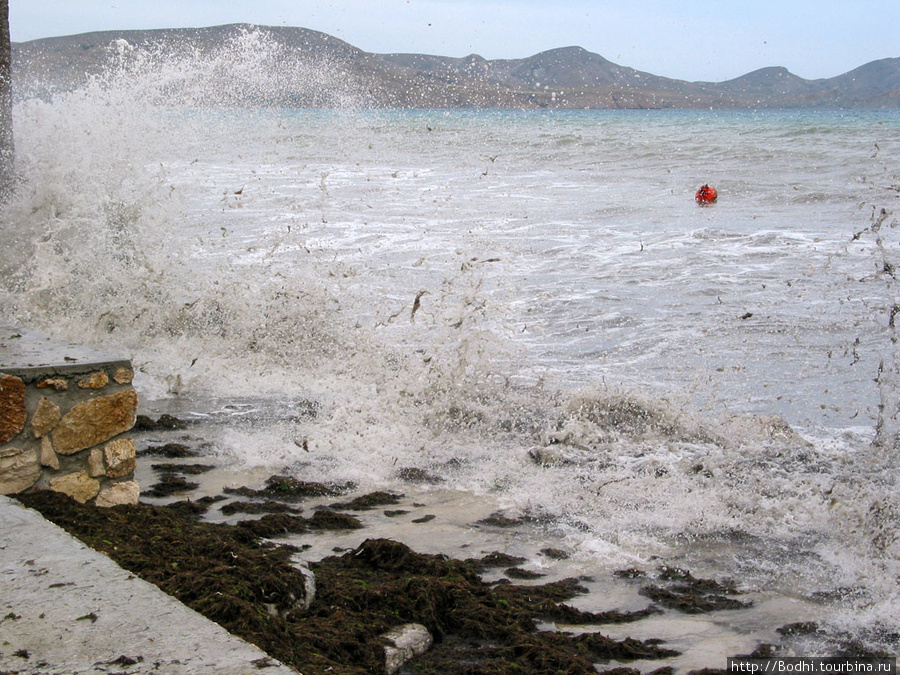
[0,321,131,382]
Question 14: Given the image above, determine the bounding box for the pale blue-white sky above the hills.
[9,0,900,81]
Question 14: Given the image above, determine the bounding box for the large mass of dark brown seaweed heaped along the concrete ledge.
[19,492,676,675]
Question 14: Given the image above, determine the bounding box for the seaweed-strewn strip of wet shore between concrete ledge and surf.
[7,418,892,675]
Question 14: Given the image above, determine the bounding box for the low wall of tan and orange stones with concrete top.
[0,323,139,506]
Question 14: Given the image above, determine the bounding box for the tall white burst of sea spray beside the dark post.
[4,30,370,394]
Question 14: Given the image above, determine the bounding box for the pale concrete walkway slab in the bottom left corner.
[0,496,297,675]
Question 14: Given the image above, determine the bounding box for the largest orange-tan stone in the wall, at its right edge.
[53,389,137,455]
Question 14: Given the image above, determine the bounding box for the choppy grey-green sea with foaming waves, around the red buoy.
[0,29,900,668]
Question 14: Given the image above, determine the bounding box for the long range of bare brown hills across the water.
[12,24,900,109]
